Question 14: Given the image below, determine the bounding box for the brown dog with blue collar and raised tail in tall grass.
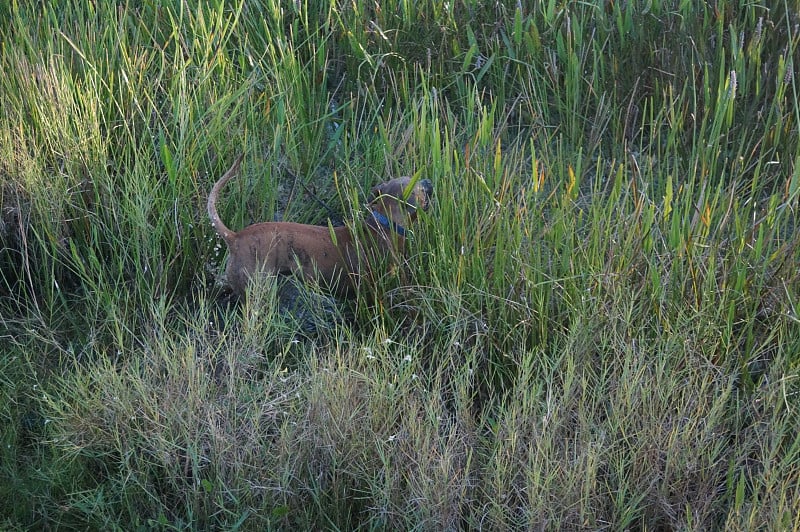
[208,155,433,295]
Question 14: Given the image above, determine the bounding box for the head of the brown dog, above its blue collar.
[369,177,433,236]
